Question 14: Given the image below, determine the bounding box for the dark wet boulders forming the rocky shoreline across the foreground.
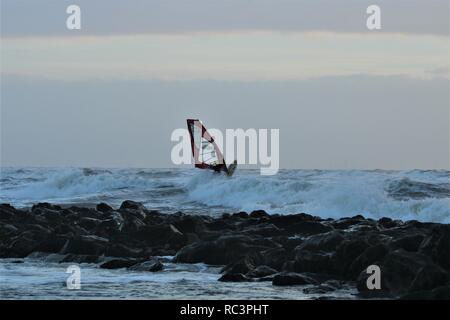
[0,201,450,299]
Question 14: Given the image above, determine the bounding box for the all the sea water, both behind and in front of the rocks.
[0,167,450,299]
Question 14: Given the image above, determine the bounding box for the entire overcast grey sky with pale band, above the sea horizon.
[0,0,450,169]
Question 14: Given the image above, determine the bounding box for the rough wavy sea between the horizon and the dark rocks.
[0,168,450,223]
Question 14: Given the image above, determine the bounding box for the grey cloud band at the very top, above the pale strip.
[1,0,449,37]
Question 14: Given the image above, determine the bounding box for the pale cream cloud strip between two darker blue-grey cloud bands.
[2,31,448,81]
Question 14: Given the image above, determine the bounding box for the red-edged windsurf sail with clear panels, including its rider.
[187,119,237,176]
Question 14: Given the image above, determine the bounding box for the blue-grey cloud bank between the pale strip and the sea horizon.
[1,75,449,170]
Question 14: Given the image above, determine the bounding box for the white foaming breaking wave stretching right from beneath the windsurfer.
[184,170,450,223]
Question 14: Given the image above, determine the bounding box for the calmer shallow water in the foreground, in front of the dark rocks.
[0,258,357,300]
